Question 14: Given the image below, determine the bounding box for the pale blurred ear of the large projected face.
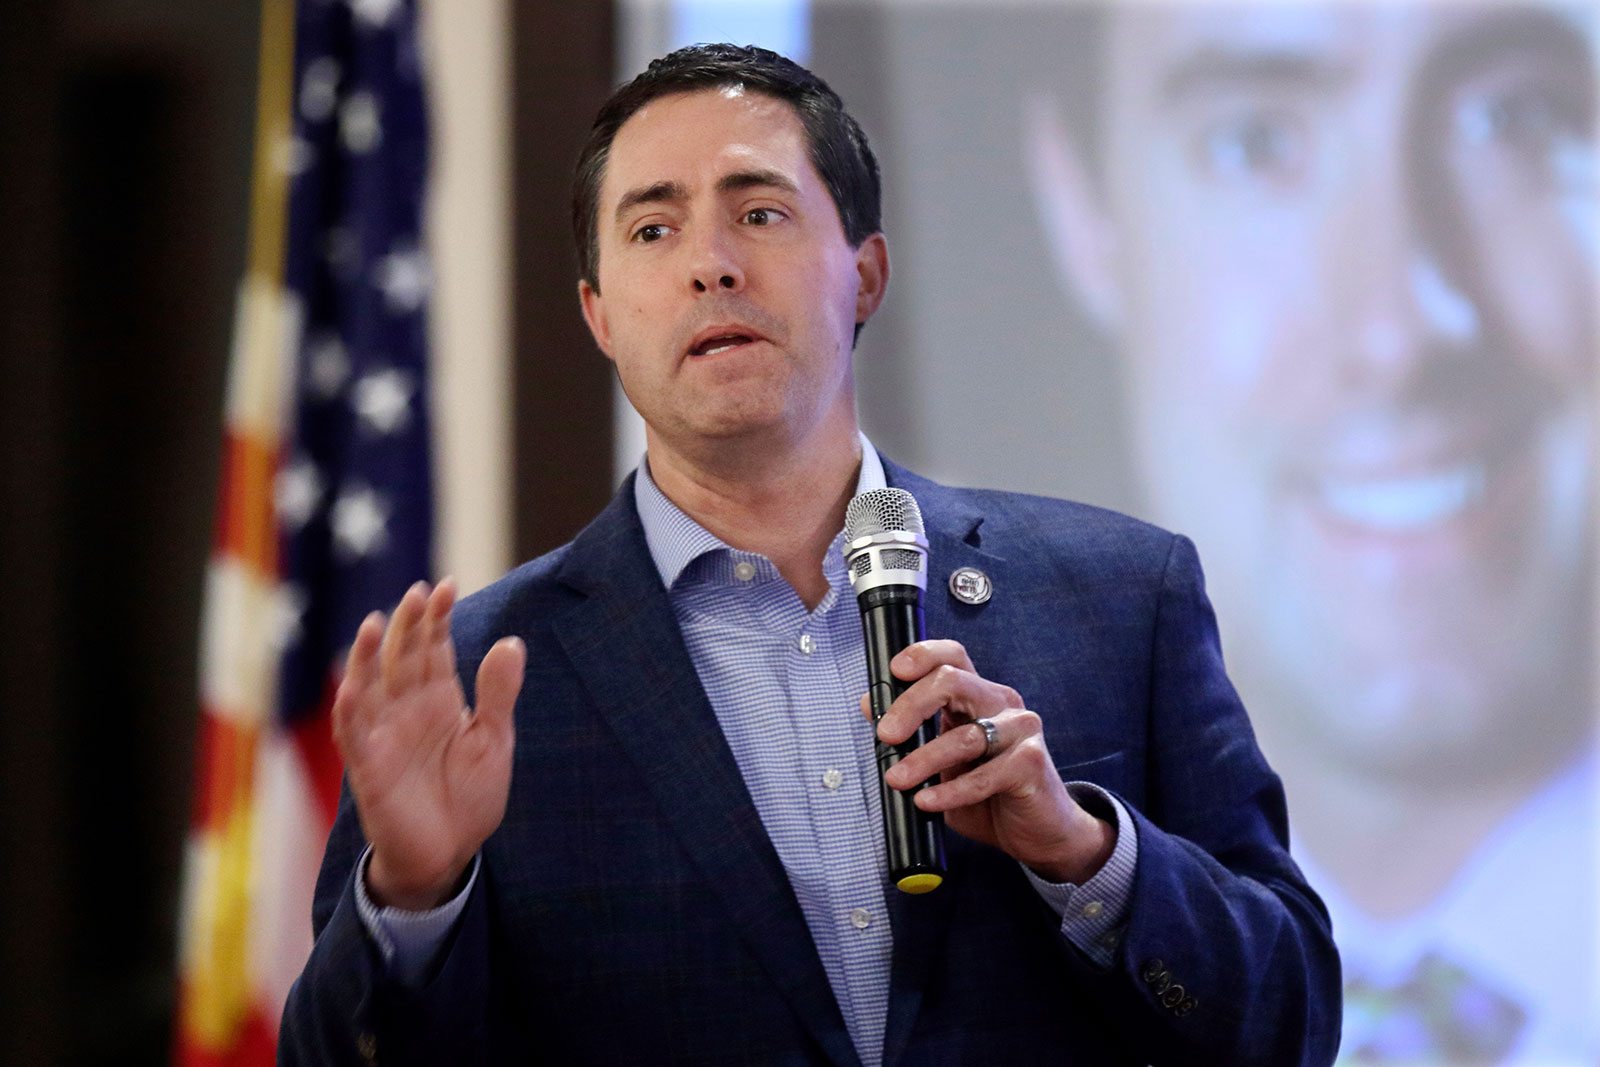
[1022,93,1123,333]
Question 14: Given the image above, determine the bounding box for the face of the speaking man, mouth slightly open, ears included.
[579,90,888,454]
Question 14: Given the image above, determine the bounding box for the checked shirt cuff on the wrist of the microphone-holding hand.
[1022,782,1139,968]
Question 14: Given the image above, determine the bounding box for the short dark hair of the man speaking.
[573,45,883,291]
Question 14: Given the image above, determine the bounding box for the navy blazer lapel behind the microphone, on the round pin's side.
[883,459,998,1064]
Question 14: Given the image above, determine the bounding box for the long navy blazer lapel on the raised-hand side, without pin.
[554,480,859,1064]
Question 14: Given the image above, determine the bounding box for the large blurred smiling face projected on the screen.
[1049,3,1597,776]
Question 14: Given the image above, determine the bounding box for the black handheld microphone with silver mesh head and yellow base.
[845,490,944,893]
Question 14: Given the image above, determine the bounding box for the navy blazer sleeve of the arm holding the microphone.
[1085,536,1341,1067]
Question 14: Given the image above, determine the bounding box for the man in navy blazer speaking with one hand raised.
[280,45,1339,1067]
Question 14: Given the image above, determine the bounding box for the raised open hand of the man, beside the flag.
[333,577,526,910]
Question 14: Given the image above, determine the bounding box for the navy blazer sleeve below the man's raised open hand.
[278,790,494,1067]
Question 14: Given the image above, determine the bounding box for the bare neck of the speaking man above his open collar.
[648,416,861,611]
